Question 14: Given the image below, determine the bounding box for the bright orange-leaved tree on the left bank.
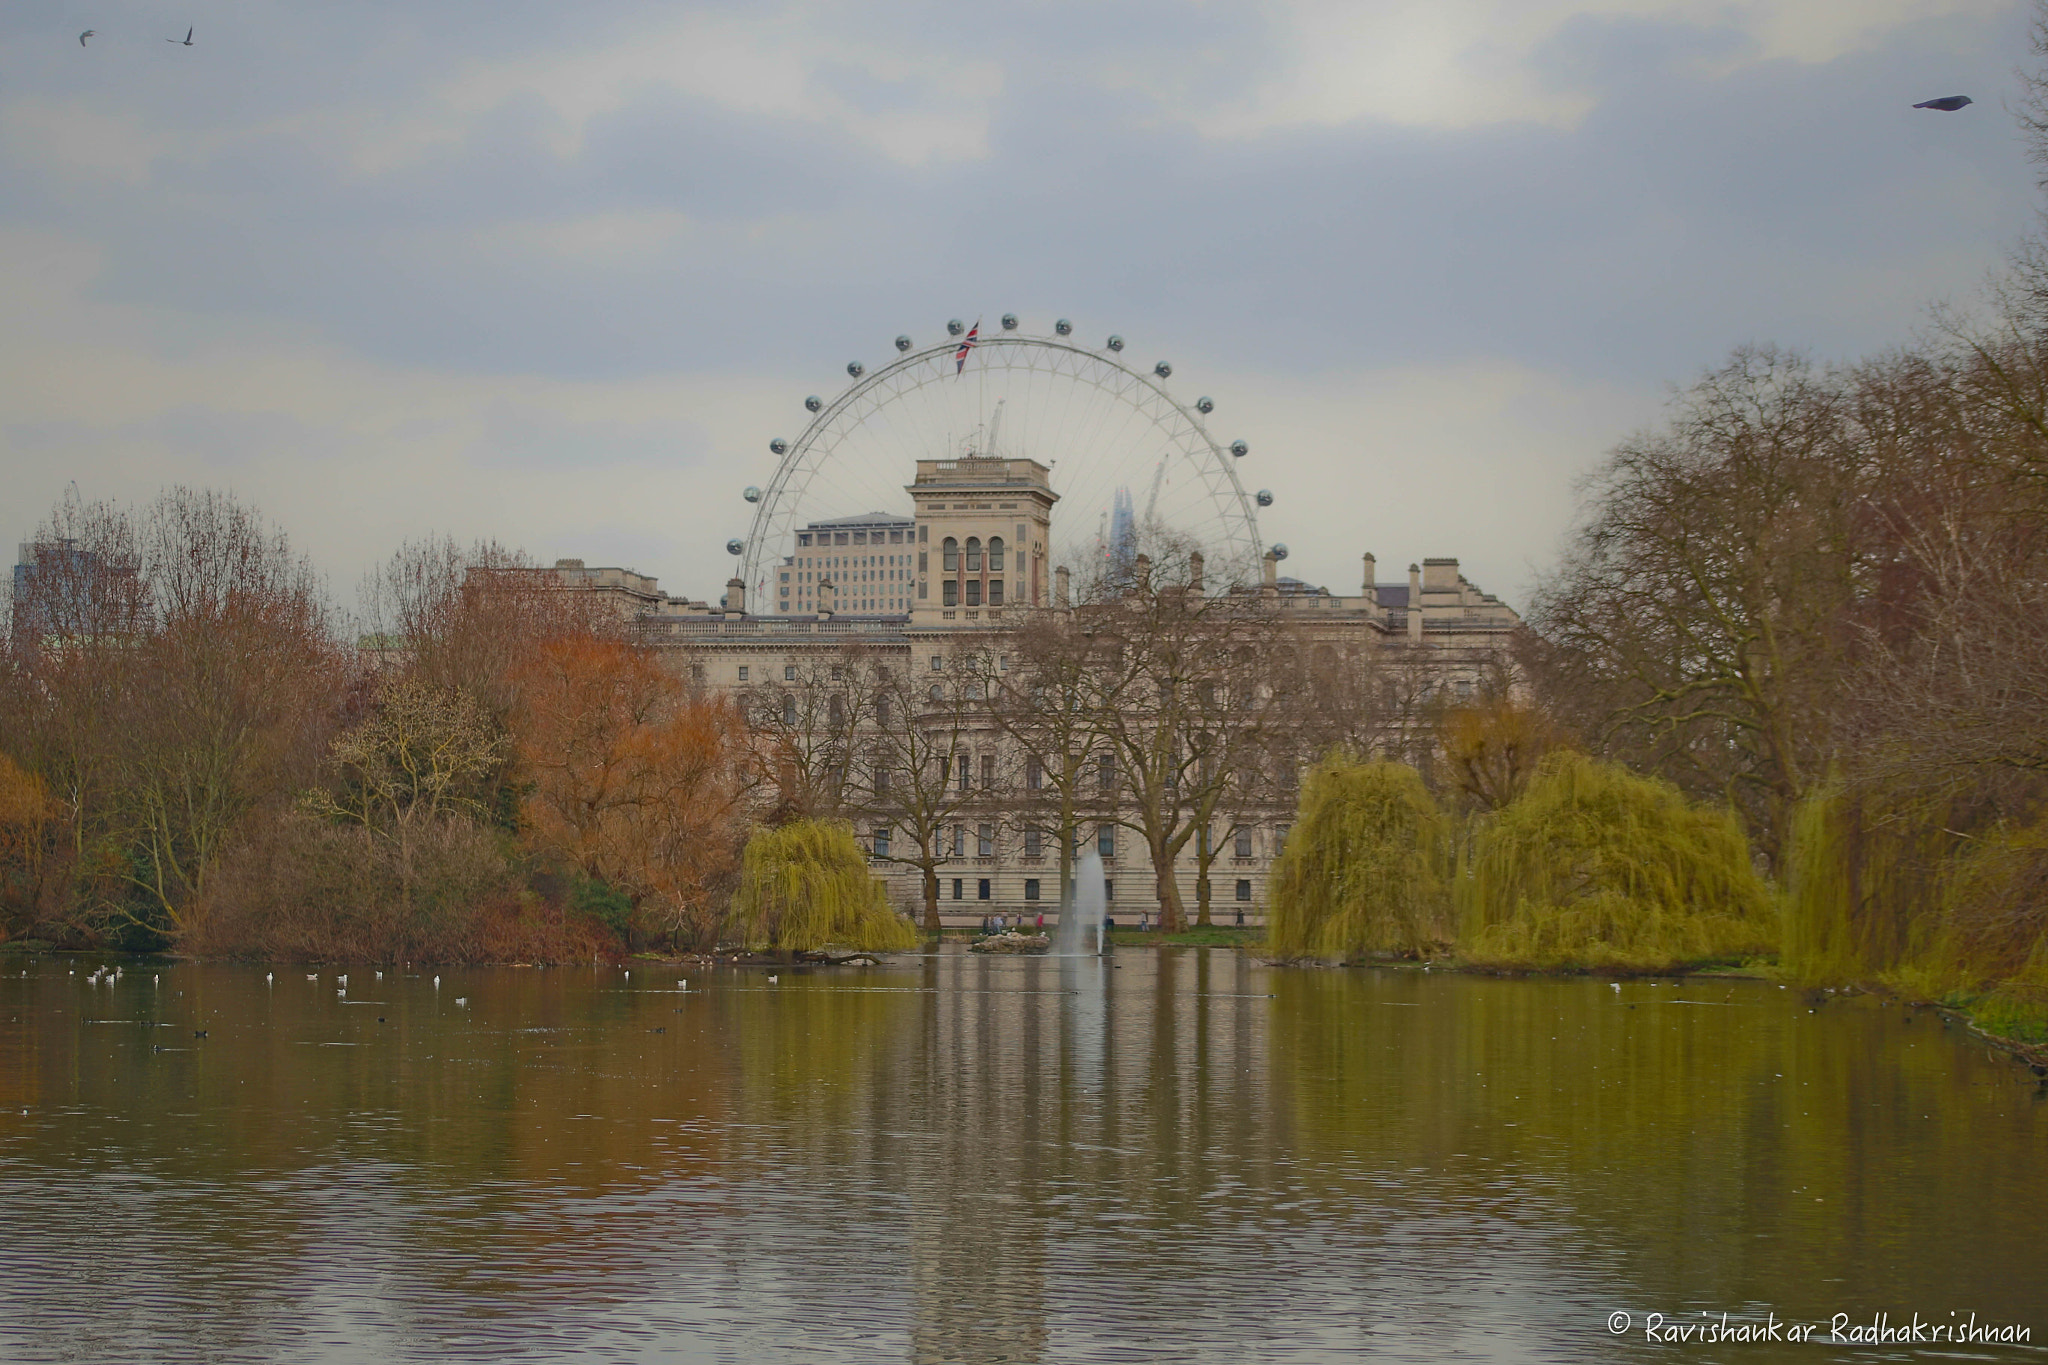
[510,632,754,948]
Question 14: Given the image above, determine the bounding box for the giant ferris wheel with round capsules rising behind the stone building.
[725,313,1286,610]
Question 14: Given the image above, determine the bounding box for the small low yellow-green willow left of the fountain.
[733,821,918,952]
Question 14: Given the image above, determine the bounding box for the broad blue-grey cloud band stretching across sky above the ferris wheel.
[20,6,2030,381]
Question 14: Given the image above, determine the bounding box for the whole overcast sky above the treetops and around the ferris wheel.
[0,0,2036,606]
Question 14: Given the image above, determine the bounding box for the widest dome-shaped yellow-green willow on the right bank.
[1458,753,1778,972]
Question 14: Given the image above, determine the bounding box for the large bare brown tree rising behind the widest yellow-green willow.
[1534,350,1872,862]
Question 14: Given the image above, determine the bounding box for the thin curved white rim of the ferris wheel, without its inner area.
[737,329,1262,593]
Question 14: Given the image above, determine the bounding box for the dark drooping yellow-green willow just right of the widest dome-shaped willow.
[1780,784,1954,986]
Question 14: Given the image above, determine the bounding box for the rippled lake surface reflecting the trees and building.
[0,948,2048,1361]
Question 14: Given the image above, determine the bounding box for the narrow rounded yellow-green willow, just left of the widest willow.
[1268,753,1450,958]
